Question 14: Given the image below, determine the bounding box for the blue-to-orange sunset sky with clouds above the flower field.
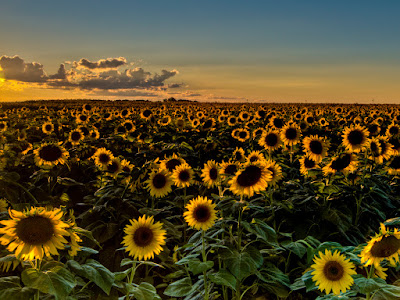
[0,0,400,104]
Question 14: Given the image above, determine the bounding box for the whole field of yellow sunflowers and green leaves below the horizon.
[0,100,400,300]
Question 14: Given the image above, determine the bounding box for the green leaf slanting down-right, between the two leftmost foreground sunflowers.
[67,259,115,295]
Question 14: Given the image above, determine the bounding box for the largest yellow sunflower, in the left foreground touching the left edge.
[0,207,70,260]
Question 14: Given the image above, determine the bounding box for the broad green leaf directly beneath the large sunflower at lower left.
[21,266,76,298]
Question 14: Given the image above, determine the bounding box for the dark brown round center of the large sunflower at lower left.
[16,216,54,245]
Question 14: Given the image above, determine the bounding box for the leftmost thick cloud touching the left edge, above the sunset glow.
[0,55,47,82]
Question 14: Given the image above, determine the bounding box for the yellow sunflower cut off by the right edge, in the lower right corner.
[360,223,400,267]
